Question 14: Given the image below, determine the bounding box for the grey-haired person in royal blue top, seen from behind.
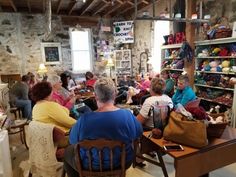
[64,78,142,177]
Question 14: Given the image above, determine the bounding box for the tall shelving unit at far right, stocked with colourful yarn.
[194,38,236,120]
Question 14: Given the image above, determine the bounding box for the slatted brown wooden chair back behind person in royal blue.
[76,139,126,177]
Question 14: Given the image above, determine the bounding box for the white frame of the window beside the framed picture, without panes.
[69,28,93,73]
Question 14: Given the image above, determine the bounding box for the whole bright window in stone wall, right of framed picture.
[70,29,92,73]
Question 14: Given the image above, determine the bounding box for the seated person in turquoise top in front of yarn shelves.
[172,75,196,106]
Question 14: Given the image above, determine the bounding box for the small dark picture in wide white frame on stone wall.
[41,42,61,65]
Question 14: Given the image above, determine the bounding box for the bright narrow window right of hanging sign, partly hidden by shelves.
[152,21,170,73]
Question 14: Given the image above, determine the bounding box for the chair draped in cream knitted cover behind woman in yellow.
[28,121,65,177]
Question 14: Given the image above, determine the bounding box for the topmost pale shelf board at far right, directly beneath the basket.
[194,37,236,46]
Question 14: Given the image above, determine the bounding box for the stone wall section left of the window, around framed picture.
[0,13,72,74]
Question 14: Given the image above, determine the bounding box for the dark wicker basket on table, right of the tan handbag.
[207,113,228,138]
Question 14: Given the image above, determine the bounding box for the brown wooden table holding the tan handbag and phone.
[143,127,236,177]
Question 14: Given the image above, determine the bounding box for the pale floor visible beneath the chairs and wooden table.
[10,135,236,177]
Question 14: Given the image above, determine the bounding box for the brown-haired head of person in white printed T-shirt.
[150,77,166,95]
